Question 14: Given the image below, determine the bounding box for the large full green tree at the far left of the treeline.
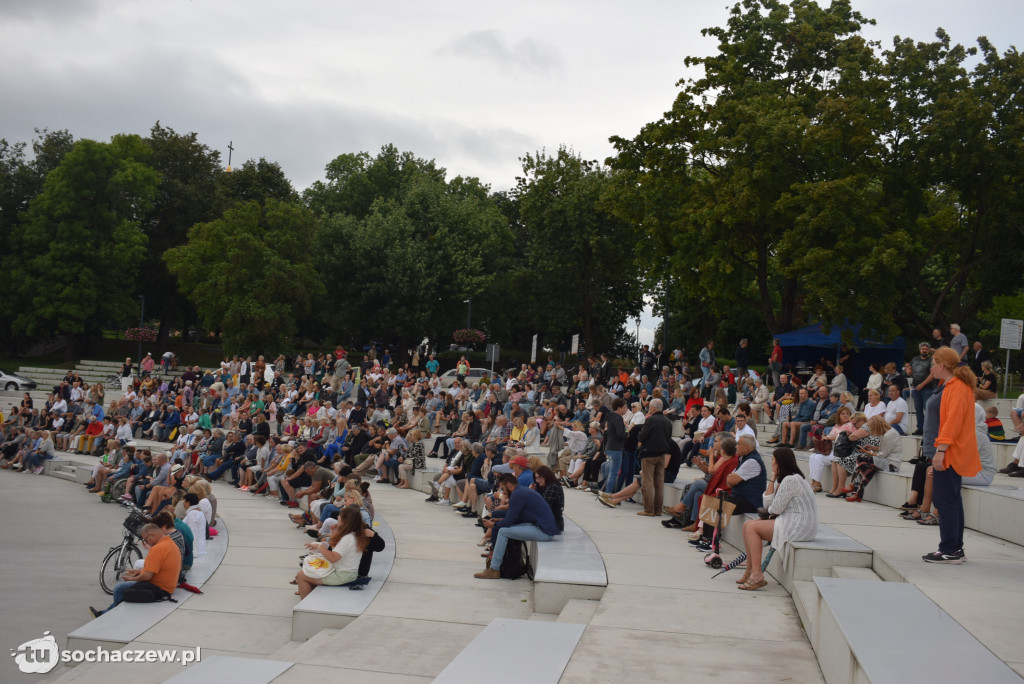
[3,135,160,358]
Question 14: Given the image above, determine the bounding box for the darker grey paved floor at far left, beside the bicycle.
[0,470,126,682]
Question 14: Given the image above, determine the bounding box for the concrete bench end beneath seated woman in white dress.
[722,513,874,594]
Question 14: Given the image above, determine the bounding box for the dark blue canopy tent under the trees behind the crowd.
[775,323,906,387]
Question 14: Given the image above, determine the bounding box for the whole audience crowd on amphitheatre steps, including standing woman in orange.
[0,329,1024,613]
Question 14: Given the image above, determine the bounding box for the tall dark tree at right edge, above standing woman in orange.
[881,29,1024,337]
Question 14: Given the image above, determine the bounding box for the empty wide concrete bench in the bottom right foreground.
[808,576,1021,684]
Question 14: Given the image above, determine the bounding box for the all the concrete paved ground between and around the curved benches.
[9,444,1024,684]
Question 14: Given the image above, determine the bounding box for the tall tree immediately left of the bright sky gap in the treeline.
[514,146,642,353]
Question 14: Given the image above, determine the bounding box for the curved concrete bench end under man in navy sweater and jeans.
[527,517,608,613]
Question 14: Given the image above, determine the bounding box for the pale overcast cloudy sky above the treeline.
[0,0,1024,338]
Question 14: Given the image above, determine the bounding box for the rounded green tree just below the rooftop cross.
[164,199,324,354]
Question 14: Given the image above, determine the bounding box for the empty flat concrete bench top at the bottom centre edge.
[434,617,587,684]
